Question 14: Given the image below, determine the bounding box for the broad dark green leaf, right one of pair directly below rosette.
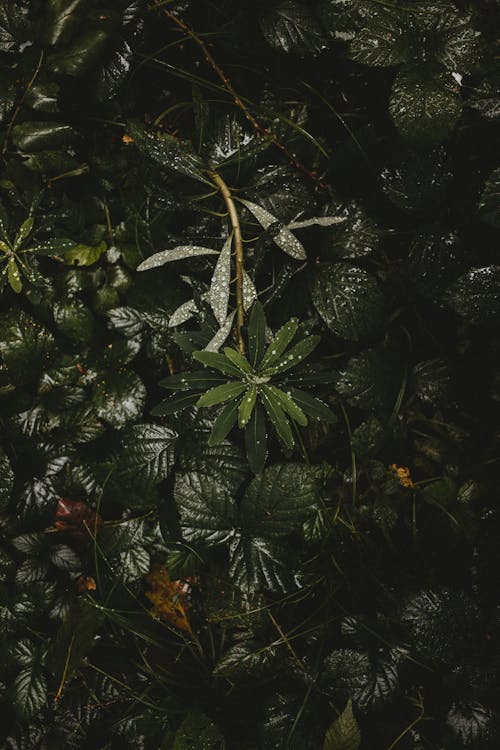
[240,464,318,537]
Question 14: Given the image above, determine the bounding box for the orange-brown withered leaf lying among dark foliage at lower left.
[146,568,193,635]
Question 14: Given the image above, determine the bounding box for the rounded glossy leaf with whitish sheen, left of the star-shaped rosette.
[93,369,146,429]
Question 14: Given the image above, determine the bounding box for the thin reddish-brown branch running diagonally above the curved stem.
[156,8,332,193]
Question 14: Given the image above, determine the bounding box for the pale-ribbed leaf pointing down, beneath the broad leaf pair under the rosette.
[229,536,293,596]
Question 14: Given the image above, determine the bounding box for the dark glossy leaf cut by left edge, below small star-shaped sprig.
[0,309,54,384]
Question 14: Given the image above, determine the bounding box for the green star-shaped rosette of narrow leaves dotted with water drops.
[152,301,336,474]
